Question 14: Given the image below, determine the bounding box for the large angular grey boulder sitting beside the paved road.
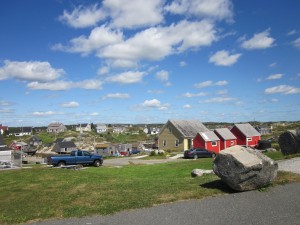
[213,145,278,191]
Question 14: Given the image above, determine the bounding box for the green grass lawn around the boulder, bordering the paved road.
[0,159,300,224]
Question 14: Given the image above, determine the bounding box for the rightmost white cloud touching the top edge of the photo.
[165,0,233,21]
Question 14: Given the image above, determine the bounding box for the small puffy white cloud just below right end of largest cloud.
[209,50,242,66]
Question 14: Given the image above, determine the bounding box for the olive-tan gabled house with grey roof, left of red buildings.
[158,120,208,151]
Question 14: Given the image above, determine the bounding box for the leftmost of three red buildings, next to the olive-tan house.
[193,131,220,153]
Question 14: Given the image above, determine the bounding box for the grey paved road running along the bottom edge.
[27,183,300,225]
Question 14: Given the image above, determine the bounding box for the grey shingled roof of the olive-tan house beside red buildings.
[169,120,208,138]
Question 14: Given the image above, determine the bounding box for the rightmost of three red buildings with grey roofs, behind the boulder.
[231,123,261,147]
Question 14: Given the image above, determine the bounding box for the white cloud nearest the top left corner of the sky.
[59,4,105,28]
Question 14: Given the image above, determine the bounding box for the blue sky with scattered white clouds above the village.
[0,0,300,126]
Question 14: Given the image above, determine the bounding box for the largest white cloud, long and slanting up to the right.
[97,21,217,65]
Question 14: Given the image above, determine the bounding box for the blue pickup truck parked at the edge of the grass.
[47,150,103,167]
